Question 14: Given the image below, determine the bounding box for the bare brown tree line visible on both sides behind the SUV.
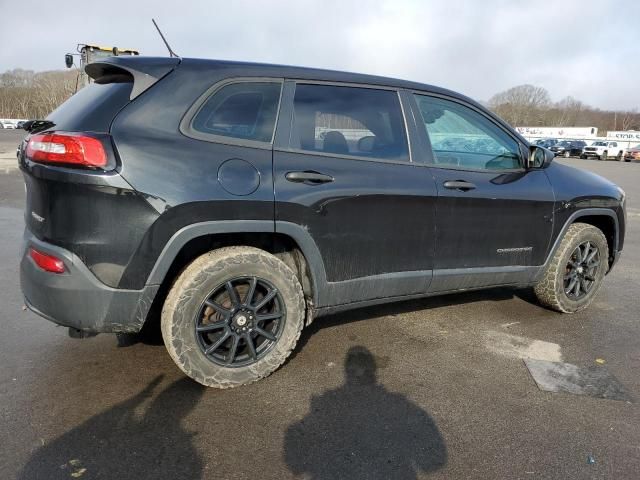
[0,69,640,134]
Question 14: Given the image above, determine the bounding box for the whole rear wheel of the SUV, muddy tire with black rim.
[161,247,305,388]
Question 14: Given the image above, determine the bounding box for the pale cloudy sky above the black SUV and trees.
[0,0,640,110]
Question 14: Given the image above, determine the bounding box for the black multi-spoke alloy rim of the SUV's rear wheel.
[194,277,286,367]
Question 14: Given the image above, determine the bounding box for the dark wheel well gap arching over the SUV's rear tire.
[143,232,315,338]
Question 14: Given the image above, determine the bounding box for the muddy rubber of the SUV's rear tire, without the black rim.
[161,246,305,388]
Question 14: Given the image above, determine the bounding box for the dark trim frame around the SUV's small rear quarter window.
[179,77,284,150]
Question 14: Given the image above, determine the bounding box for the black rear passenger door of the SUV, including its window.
[274,81,436,306]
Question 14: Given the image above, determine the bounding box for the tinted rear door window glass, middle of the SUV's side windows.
[289,84,409,161]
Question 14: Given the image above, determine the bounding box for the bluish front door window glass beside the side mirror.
[414,94,521,170]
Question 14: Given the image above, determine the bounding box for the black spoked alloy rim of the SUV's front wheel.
[564,241,600,300]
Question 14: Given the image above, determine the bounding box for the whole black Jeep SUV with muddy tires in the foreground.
[19,57,625,387]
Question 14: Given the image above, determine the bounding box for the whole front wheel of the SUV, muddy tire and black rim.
[534,223,609,313]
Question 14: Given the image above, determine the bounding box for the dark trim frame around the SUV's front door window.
[407,90,527,173]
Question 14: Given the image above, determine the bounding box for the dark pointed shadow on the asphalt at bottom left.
[19,376,205,480]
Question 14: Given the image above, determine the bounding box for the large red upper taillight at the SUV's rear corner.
[27,132,108,168]
